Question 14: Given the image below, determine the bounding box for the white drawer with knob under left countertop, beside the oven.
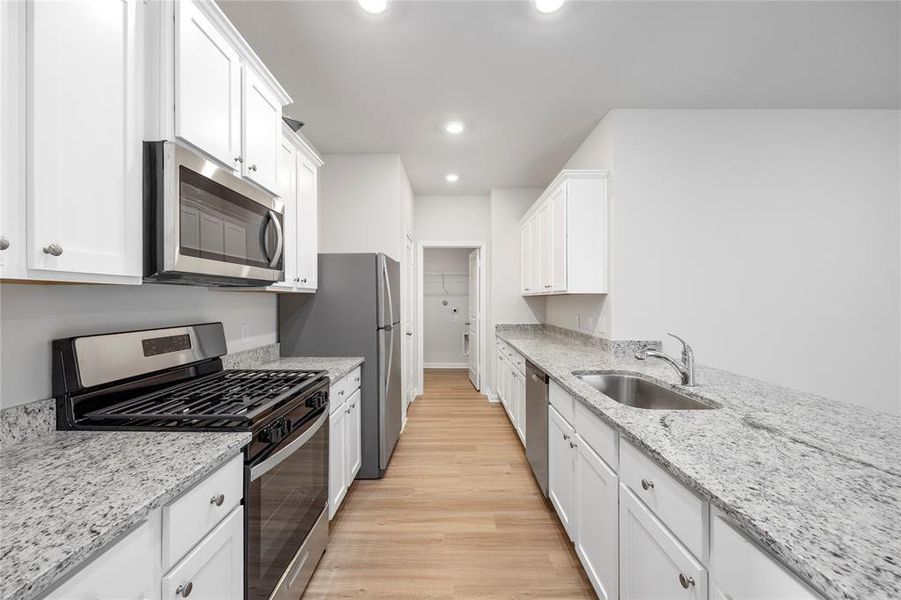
[163,454,244,570]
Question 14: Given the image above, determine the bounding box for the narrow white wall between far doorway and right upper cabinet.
[488,188,546,392]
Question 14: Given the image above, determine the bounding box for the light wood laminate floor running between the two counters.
[304,370,595,600]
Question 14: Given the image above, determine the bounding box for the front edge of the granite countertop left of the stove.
[3,433,251,600]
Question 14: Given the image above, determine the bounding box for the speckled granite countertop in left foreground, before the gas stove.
[0,431,250,600]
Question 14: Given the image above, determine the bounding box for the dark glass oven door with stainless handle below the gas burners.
[245,405,329,600]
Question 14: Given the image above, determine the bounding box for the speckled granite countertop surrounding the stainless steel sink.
[497,326,901,600]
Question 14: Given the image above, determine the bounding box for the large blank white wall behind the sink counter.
[548,110,901,413]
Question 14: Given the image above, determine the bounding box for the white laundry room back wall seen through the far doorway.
[422,248,472,369]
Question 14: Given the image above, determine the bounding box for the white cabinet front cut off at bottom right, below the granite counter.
[710,514,819,600]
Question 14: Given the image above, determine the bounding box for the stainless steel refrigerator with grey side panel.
[278,254,402,479]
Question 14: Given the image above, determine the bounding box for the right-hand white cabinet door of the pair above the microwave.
[241,66,282,191]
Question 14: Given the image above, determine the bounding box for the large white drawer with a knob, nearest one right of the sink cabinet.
[619,443,708,557]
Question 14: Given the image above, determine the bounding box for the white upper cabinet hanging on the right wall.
[521,171,608,295]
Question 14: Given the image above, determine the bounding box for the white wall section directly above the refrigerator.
[319,154,402,261]
